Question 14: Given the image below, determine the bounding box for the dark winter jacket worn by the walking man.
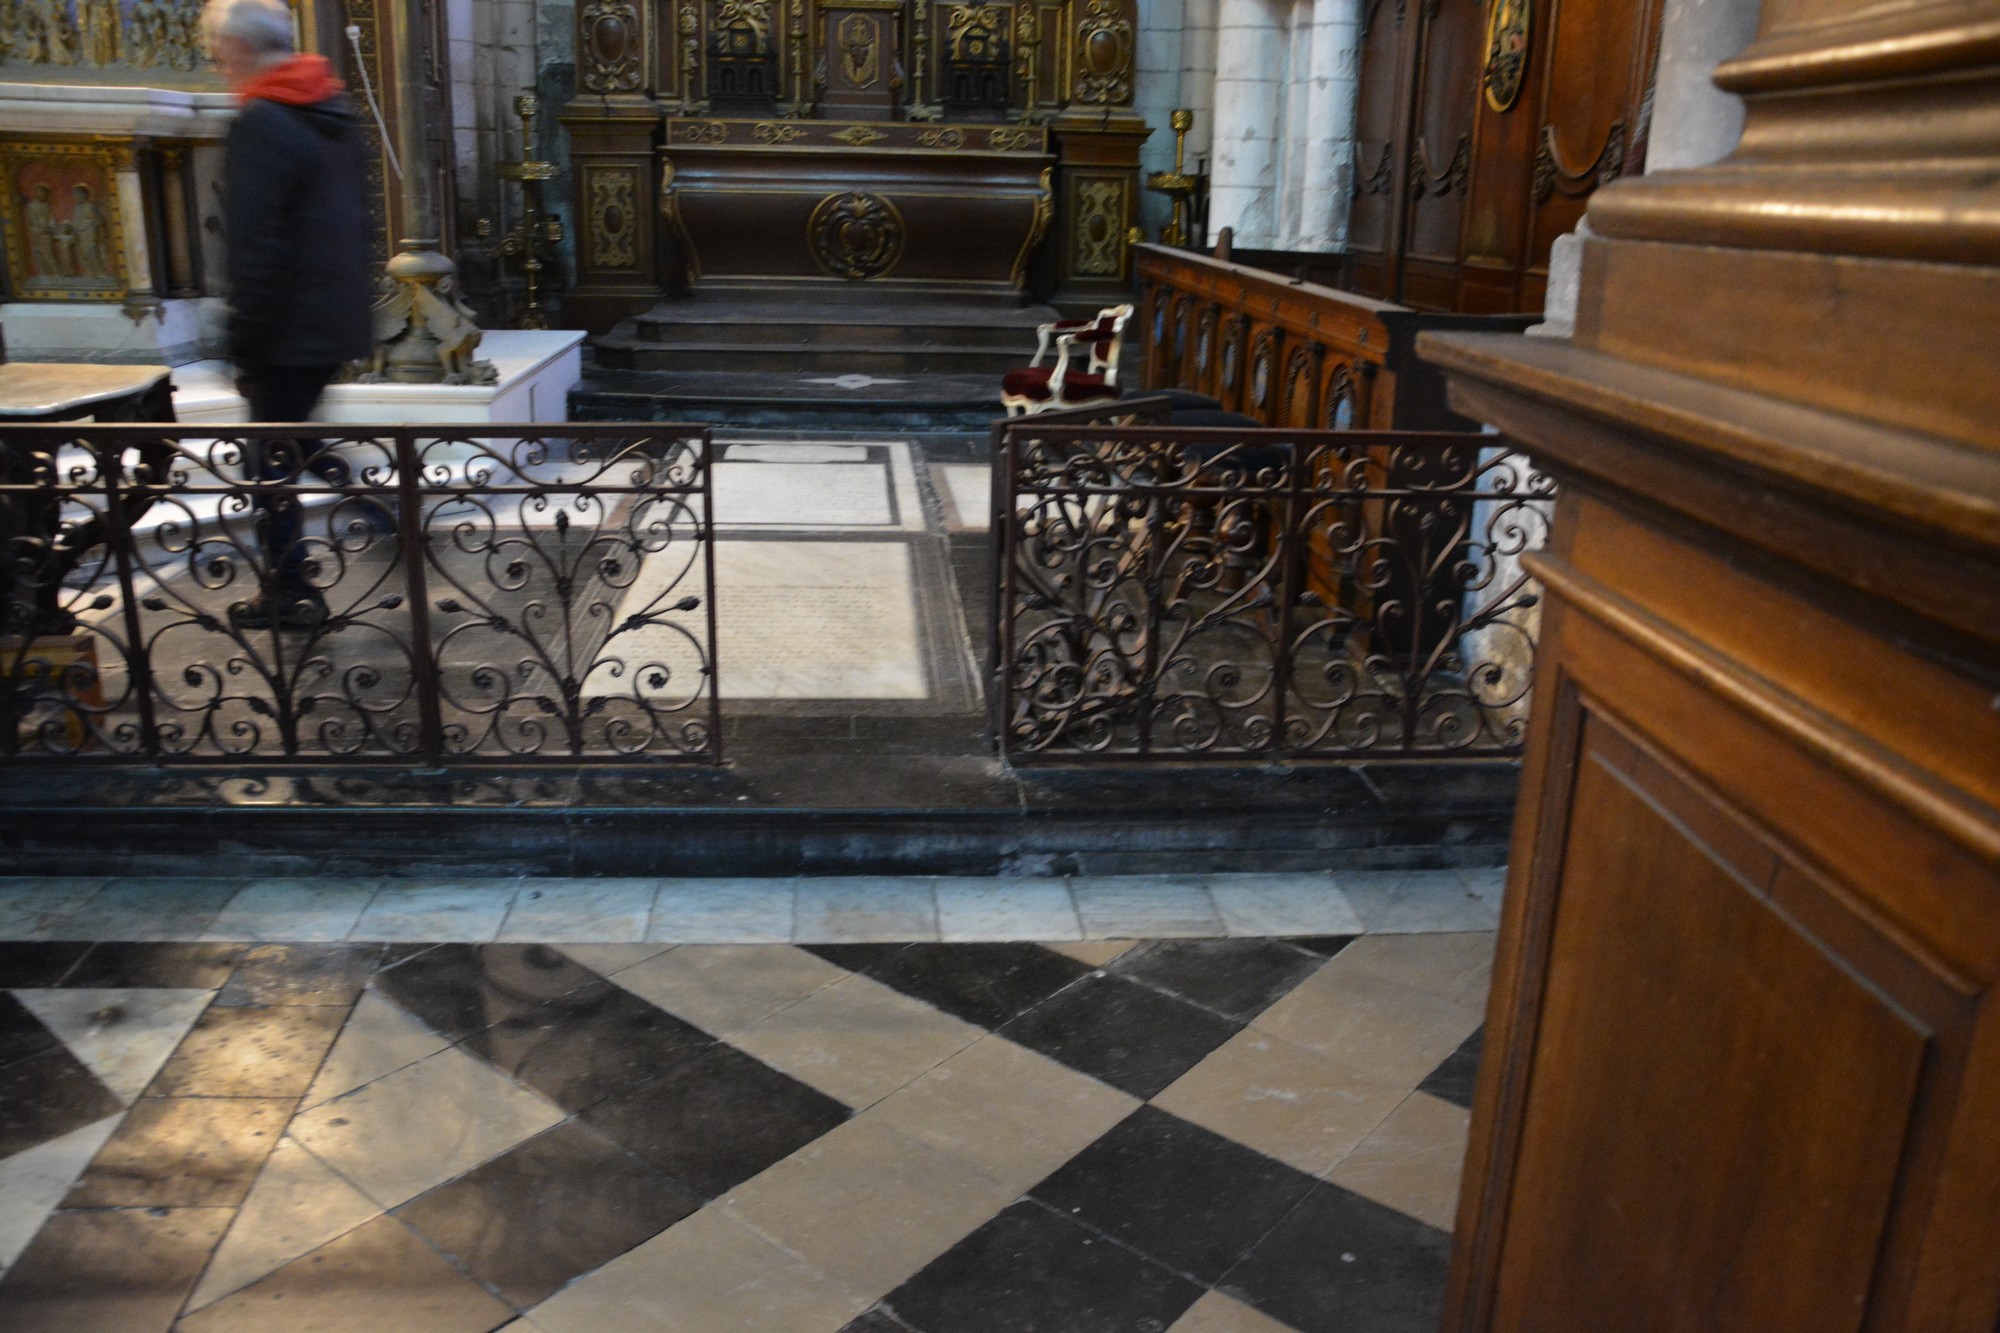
[222,70,376,366]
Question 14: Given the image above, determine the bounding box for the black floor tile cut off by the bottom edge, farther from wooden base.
[882,1199,1202,1333]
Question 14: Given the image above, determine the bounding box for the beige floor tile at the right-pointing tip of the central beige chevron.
[866,1037,1140,1191]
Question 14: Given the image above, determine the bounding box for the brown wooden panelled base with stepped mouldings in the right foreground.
[1420,0,2000,1333]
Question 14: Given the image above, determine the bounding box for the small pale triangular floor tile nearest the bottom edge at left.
[188,1135,382,1311]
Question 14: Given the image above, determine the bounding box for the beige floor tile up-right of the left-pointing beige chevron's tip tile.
[1250,945,1480,1089]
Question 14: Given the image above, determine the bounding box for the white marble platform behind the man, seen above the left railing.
[174,328,584,424]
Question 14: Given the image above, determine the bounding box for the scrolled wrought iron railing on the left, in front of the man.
[0,422,722,767]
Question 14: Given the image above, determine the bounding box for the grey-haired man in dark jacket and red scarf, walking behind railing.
[202,0,374,628]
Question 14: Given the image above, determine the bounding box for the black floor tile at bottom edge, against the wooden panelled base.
[1216,1183,1452,1333]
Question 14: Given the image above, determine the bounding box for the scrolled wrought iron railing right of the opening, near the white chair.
[992,418,1554,763]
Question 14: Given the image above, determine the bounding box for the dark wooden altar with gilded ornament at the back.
[562,0,1150,332]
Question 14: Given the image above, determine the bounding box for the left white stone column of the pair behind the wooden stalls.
[1208,0,1284,248]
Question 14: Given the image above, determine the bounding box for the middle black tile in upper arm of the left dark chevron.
[464,981,714,1113]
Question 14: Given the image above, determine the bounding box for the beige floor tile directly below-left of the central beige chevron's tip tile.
[724,1117,1020,1293]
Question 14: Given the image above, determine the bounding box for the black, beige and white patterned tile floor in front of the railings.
[0,873,1492,1333]
